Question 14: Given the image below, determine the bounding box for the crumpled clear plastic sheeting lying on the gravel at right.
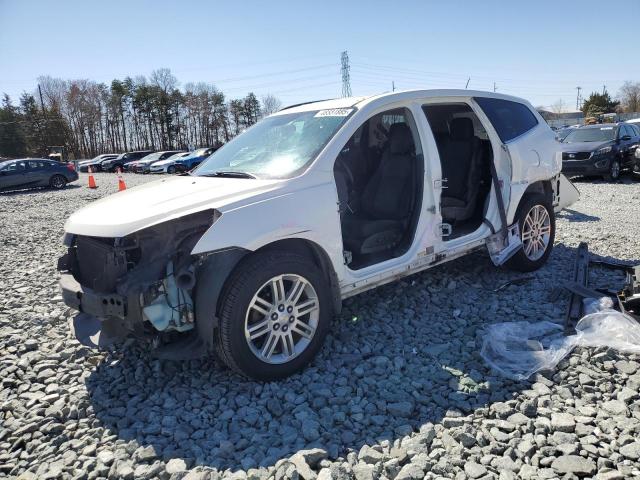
[480,298,640,380]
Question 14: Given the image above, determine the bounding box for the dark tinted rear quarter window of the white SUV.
[475,97,538,142]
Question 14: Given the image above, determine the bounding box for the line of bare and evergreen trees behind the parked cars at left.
[0,68,281,158]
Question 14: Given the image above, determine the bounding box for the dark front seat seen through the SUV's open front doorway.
[342,123,416,255]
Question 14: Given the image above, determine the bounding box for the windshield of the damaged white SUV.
[193,108,353,178]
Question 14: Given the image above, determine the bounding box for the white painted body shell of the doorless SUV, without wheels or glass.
[65,90,577,297]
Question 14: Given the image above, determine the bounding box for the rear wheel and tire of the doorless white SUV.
[507,193,556,272]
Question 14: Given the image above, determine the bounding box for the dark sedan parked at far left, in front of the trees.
[0,158,78,190]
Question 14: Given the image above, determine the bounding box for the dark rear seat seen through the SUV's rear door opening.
[440,118,482,222]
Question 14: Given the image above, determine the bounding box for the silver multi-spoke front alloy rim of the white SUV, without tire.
[244,274,320,364]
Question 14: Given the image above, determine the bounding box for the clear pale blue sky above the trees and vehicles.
[0,0,640,110]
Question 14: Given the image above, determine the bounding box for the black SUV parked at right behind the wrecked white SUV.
[562,123,640,180]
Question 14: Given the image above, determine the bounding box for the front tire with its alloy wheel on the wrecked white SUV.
[214,252,332,381]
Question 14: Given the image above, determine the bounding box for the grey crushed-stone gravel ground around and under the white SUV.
[0,174,640,480]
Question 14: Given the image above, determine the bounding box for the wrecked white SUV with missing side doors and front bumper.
[58,90,578,380]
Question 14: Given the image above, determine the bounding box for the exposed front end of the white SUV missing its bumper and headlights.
[58,210,220,347]
